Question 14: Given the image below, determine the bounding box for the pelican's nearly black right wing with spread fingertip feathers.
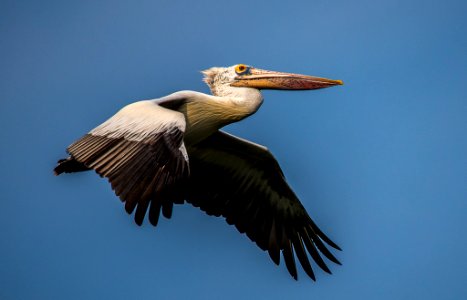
[187,131,340,280]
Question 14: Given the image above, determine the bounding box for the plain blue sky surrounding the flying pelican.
[0,0,467,299]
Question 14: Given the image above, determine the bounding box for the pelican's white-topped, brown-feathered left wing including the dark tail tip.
[55,100,189,225]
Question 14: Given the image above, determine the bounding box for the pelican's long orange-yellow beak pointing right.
[230,67,344,90]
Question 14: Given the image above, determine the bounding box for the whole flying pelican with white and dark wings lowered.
[54,64,343,281]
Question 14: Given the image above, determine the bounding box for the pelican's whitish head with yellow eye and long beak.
[203,64,343,96]
